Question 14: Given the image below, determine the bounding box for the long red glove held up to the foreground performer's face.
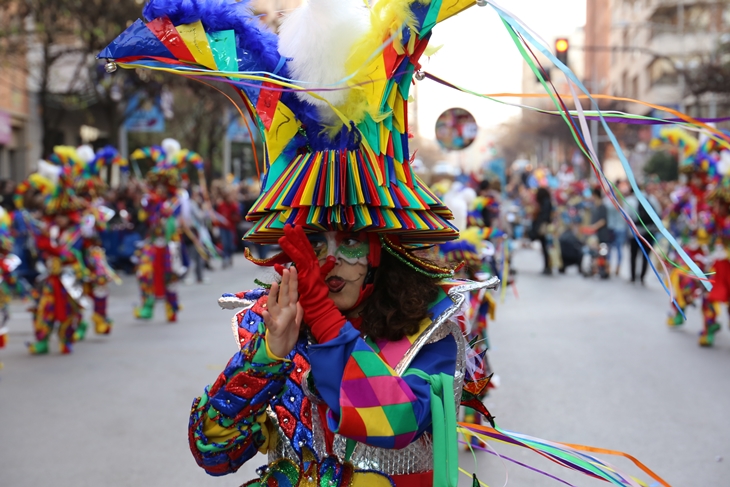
[279,225,347,343]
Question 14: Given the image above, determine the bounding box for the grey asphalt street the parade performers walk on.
[0,250,730,487]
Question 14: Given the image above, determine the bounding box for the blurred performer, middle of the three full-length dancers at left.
[74,146,127,341]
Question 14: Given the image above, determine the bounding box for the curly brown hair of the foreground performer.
[360,250,439,341]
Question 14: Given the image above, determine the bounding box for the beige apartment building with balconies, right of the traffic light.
[610,0,730,116]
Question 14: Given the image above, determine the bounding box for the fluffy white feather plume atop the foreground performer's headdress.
[279,0,370,119]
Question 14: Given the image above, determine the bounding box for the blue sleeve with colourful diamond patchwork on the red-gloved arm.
[310,323,456,448]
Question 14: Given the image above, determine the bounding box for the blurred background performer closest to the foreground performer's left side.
[133,139,187,323]
